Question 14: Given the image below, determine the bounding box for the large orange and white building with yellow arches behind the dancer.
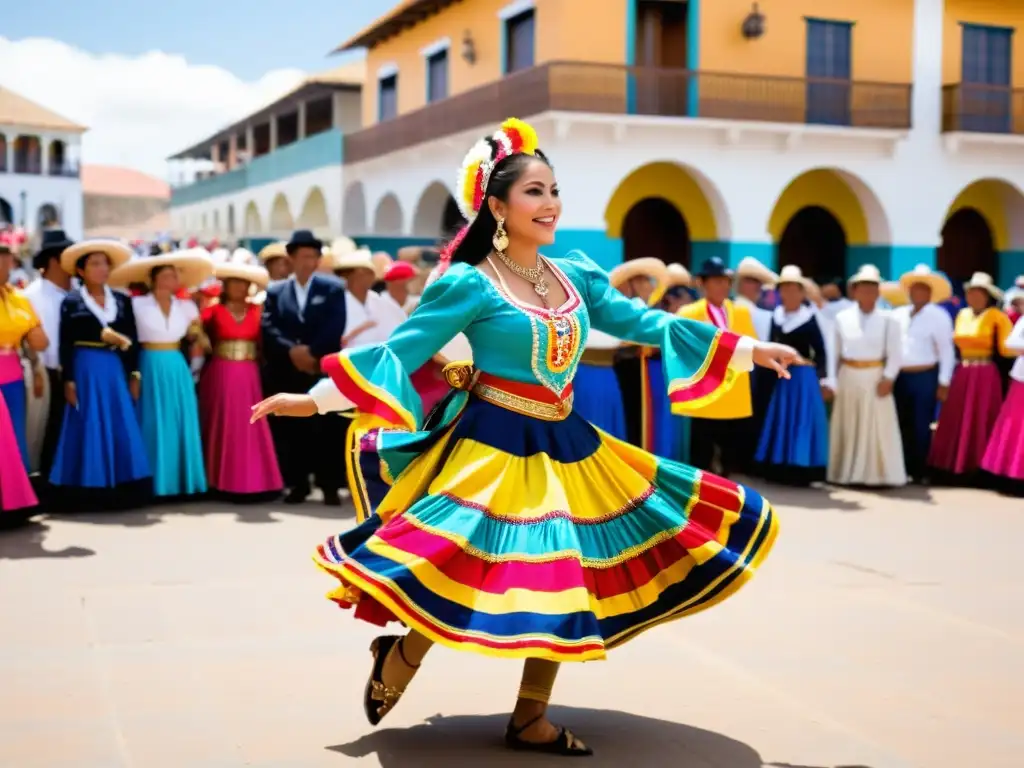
[335,0,1024,283]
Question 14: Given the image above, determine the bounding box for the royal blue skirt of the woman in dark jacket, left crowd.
[50,347,150,488]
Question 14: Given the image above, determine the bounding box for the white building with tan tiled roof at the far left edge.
[0,87,86,238]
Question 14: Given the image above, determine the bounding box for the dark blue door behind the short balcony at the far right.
[959,24,1013,133]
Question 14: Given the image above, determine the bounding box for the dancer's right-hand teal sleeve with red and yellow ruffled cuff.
[559,251,754,415]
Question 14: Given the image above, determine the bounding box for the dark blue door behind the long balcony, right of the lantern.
[806,18,853,125]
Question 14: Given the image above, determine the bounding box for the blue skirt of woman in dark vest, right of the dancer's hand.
[755,366,828,479]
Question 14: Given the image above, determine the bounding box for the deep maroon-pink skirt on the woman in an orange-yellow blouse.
[928,362,1002,475]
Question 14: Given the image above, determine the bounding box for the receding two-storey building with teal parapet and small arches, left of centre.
[164,61,364,240]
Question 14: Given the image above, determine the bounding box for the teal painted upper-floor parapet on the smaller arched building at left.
[171,128,344,208]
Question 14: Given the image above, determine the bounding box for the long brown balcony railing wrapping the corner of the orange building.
[344,61,910,163]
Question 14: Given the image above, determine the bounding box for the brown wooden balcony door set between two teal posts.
[634,0,689,117]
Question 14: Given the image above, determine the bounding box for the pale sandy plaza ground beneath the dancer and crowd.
[0,486,1024,768]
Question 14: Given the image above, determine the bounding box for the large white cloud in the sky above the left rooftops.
[0,37,305,178]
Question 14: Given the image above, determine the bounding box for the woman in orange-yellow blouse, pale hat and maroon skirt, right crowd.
[928,272,1013,482]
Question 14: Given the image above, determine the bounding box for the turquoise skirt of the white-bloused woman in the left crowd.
[138,349,206,496]
